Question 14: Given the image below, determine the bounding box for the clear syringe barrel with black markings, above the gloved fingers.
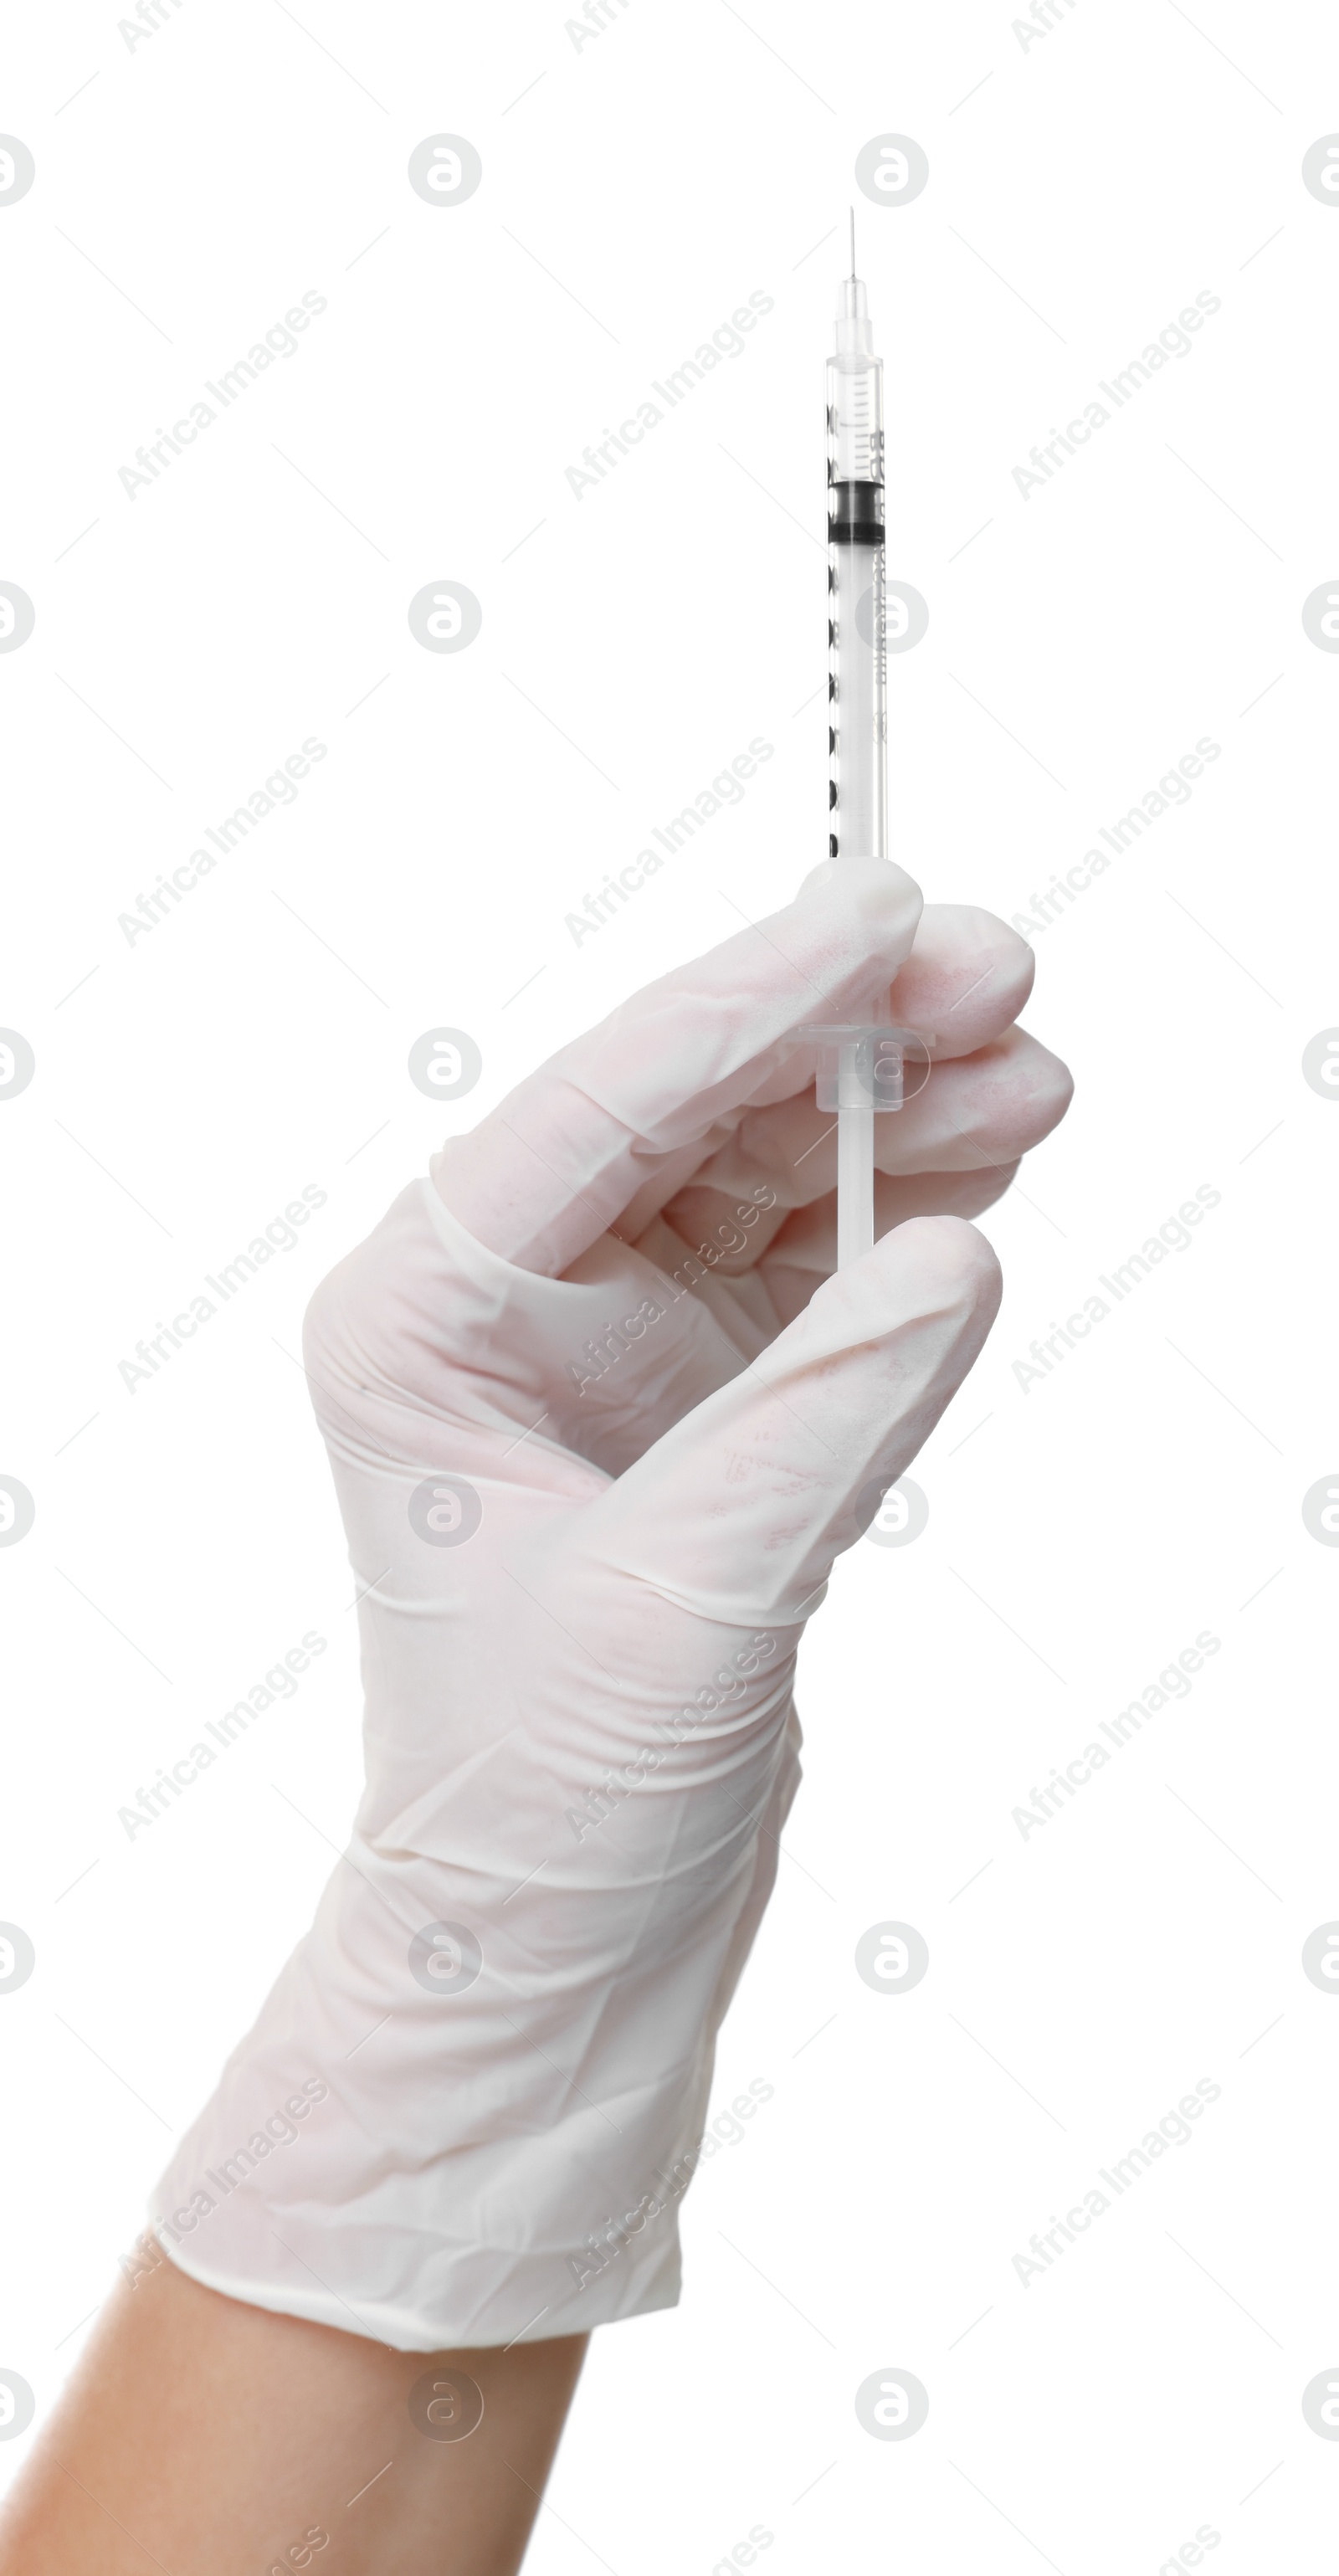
[827,324,889,858]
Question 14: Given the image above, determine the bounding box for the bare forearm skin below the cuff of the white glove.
[0,2261,587,2576]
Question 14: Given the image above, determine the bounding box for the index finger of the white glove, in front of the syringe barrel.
[433,860,922,1278]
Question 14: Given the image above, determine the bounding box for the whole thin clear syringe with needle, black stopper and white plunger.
[798,211,932,1270]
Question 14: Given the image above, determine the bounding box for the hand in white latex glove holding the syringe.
[157,860,1069,2349]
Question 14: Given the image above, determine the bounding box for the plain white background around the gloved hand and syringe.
[0,0,1339,2576]
